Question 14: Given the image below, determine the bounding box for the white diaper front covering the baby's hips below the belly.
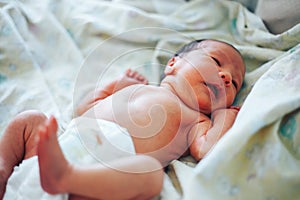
[59,117,135,164]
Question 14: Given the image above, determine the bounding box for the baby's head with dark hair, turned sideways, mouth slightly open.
[162,40,245,114]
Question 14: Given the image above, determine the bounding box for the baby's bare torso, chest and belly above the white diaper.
[83,84,210,164]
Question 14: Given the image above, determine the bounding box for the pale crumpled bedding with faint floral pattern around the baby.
[0,0,300,200]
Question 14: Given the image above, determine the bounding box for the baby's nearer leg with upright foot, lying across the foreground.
[37,117,163,199]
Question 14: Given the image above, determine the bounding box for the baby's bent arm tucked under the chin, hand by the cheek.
[190,106,239,161]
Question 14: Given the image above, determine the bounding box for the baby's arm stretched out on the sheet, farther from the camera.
[75,69,148,116]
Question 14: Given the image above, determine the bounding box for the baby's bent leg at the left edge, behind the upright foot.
[0,110,47,199]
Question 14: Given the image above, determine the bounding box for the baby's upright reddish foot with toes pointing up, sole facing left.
[37,117,70,194]
